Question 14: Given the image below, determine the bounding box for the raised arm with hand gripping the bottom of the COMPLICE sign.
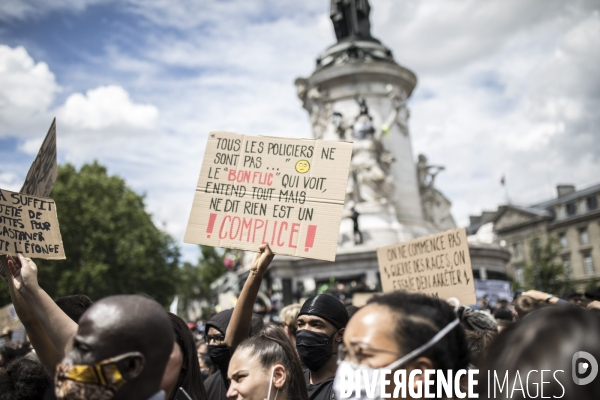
[225,244,275,353]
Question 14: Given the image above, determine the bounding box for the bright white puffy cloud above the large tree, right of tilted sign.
[58,85,158,131]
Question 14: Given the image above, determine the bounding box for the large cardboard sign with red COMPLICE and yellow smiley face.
[184,132,352,261]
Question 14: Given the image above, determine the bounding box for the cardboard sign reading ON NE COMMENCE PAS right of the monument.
[377,228,476,304]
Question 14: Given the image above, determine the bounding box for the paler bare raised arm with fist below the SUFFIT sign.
[8,254,77,358]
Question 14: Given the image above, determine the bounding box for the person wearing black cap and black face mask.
[296,294,349,400]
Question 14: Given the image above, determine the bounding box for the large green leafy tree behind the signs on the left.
[0,162,179,305]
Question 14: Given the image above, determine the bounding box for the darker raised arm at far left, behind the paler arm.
[4,256,61,373]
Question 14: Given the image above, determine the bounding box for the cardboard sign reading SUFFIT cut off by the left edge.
[0,189,65,260]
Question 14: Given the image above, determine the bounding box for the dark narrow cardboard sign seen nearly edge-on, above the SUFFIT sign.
[21,118,58,197]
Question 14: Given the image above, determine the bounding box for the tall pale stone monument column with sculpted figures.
[296,0,435,251]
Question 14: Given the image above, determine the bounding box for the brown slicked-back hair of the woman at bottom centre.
[236,325,308,400]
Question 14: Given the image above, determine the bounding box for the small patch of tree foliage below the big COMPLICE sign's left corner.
[177,246,227,309]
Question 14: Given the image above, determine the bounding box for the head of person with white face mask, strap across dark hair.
[333,292,470,399]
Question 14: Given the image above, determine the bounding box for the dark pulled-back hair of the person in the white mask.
[367,292,470,372]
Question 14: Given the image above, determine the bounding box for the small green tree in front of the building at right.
[524,236,570,295]
